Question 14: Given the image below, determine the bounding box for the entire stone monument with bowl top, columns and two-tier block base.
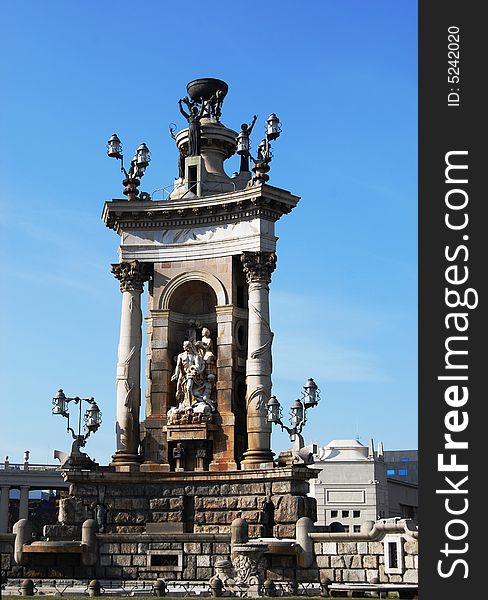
[13,79,316,585]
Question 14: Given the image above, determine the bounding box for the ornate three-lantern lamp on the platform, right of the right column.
[268,377,320,464]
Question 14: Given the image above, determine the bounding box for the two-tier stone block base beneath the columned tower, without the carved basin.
[1,466,316,581]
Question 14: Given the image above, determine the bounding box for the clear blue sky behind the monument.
[0,0,417,463]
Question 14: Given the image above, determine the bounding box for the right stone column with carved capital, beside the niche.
[241,252,276,469]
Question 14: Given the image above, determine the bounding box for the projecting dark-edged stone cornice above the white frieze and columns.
[102,184,300,235]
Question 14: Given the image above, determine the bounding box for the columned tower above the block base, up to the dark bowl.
[103,79,299,471]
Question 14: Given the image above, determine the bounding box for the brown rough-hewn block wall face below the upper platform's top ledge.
[45,476,316,540]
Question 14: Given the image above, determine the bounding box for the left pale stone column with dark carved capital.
[112,260,150,465]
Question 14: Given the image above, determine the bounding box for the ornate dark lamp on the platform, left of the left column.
[52,390,102,468]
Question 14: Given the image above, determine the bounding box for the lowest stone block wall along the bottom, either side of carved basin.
[4,516,418,584]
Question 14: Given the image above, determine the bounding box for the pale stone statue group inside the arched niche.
[168,323,216,425]
